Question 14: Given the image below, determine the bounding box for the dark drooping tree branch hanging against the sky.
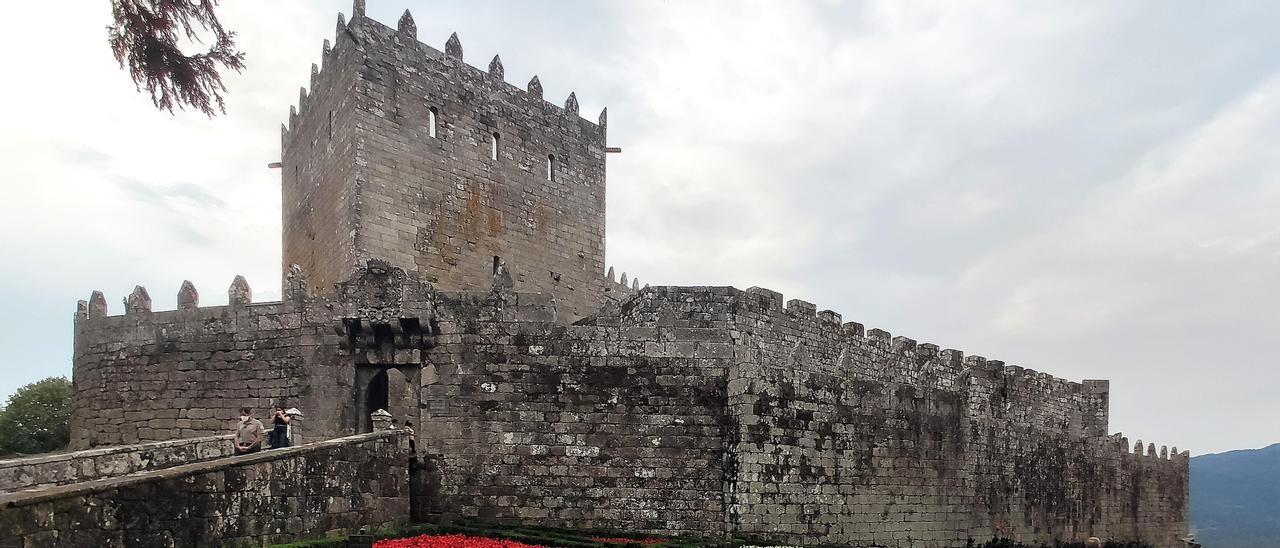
[106,0,244,117]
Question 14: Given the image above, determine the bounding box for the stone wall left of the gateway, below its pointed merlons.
[70,301,309,449]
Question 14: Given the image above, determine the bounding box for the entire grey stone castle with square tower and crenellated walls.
[35,0,1188,548]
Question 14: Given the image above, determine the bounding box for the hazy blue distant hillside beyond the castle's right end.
[1190,443,1280,548]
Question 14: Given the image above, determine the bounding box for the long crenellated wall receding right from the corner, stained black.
[721,288,1187,547]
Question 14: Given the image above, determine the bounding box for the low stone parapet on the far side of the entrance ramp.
[0,434,234,493]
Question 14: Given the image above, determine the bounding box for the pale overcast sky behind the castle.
[0,0,1280,455]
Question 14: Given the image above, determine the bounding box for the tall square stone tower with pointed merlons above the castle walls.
[282,0,614,320]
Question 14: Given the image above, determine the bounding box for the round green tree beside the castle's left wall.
[0,376,73,455]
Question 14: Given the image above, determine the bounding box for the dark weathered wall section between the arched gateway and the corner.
[419,293,731,533]
